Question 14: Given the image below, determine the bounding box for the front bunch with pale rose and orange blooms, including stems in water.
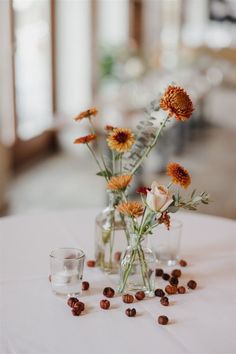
[117,162,209,294]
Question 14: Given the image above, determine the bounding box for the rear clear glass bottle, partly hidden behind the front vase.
[95,191,129,273]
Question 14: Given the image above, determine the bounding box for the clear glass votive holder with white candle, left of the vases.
[50,248,85,297]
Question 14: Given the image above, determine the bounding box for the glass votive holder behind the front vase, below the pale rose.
[150,219,183,266]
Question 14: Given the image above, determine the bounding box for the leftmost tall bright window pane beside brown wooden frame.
[13,0,52,139]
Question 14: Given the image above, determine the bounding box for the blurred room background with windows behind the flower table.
[0,0,236,219]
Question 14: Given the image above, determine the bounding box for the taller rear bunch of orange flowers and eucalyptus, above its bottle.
[74,85,194,183]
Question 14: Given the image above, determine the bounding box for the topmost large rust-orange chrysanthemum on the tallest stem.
[160,85,194,121]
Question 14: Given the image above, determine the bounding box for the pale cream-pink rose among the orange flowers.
[146,181,173,213]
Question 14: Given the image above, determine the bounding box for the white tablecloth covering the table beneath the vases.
[0,209,236,354]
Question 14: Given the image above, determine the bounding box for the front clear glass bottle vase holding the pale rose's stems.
[118,234,156,297]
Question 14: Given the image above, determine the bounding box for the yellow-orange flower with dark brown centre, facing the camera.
[107,128,134,153]
